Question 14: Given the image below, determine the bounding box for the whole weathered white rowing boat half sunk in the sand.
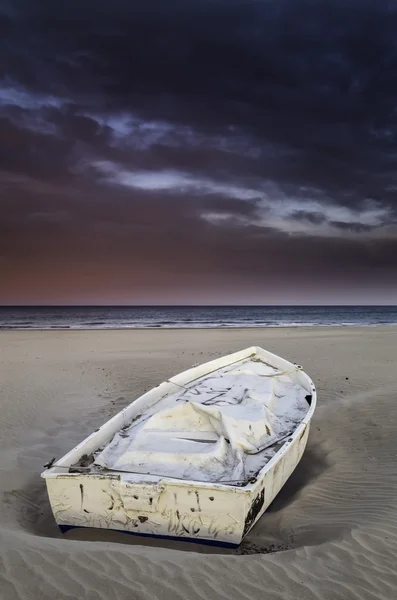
[42,347,316,546]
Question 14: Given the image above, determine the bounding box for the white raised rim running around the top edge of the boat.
[41,346,317,493]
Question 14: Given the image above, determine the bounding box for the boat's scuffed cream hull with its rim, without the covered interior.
[42,347,316,546]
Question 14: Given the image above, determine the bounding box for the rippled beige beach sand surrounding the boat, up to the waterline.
[0,327,397,600]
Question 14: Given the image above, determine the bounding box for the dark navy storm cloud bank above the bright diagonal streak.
[1,0,397,196]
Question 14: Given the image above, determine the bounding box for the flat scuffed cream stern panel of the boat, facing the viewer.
[43,472,250,546]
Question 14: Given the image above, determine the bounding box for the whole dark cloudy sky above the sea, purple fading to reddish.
[0,0,397,304]
